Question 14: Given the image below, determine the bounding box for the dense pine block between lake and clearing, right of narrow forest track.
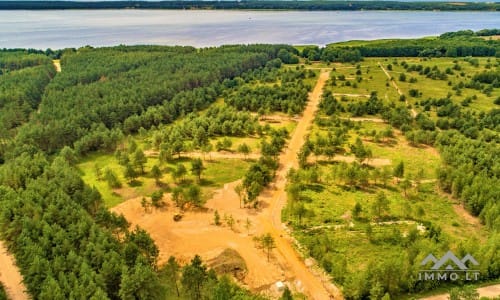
[6,45,292,154]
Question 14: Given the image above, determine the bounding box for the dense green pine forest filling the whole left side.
[0,45,295,299]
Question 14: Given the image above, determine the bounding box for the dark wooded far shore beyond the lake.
[0,0,500,11]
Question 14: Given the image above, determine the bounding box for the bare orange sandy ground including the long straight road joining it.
[112,70,341,300]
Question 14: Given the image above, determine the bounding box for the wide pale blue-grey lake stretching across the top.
[0,9,500,49]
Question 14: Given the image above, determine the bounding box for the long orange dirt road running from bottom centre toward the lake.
[260,71,342,300]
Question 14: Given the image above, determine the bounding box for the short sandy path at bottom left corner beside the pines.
[0,241,29,300]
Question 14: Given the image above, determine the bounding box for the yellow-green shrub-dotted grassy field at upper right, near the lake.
[327,56,500,115]
